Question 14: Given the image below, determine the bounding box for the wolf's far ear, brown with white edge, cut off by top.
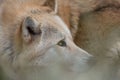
[44,0,58,14]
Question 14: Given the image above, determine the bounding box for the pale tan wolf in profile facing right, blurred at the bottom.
[0,0,94,80]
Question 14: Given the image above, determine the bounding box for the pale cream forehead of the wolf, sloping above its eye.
[27,9,71,36]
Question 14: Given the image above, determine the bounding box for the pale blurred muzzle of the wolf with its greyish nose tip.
[68,48,96,73]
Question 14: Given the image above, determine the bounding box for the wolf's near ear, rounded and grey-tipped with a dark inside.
[22,17,41,43]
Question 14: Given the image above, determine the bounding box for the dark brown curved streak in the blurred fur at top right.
[94,4,120,12]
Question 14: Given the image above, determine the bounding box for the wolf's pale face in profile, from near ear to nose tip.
[14,14,92,80]
